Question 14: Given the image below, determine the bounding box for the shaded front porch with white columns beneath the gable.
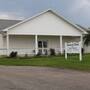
[0,34,82,56]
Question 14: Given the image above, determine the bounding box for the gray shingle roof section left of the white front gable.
[0,19,21,31]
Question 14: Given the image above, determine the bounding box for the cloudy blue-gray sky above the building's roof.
[0,0,90,27]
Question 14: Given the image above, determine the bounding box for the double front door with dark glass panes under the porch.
[38,41,48,55]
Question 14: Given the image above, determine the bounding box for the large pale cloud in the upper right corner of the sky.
[68,0,90,27]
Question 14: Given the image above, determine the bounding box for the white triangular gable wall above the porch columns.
[9,12,82,36]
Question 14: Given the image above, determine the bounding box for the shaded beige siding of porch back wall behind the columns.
[4,35,80,54]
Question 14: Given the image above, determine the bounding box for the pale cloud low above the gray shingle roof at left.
[0,12,25,20]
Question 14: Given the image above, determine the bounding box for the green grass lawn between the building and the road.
[0,54,90,71]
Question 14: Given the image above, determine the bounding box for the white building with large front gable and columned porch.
[0,10,87,55]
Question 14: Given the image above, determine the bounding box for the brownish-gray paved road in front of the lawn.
[0,66,90,90]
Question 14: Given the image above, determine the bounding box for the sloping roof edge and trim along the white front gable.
[2,9,87,34]
